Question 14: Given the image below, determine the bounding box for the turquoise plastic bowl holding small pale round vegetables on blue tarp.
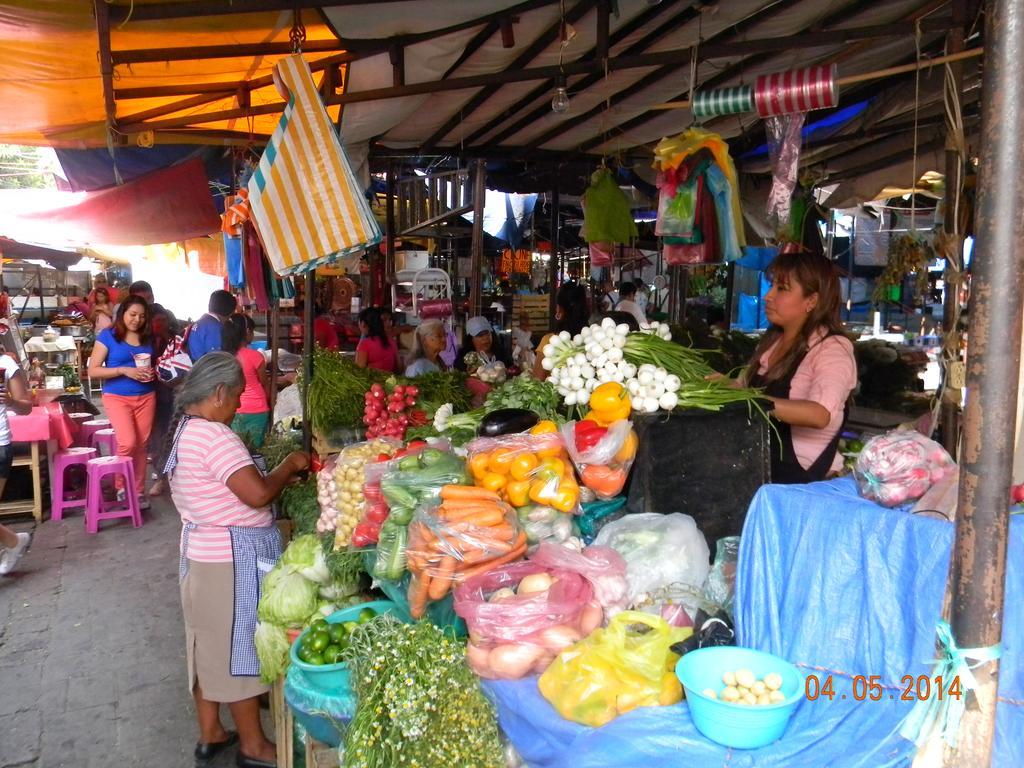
[676,646,804,750]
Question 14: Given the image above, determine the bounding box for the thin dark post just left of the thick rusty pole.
[940,0,967,456]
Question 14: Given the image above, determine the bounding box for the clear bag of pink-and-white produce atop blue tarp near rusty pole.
[853,431,956,507]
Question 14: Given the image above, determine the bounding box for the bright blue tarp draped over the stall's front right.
[485,479,1024,768]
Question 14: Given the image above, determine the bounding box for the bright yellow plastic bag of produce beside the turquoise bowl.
[538,610,692,727]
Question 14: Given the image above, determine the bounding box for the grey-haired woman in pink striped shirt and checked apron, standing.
[164,352,308,768]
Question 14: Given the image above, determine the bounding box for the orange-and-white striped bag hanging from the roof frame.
[249,54,381,275]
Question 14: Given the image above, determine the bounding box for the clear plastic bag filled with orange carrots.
[406,501,526,618]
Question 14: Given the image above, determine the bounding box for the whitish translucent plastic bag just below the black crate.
[594,512,711,605]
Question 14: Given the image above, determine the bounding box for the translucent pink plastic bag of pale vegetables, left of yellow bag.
[455,562,604,680]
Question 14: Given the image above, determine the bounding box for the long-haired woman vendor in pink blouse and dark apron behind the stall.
[741,253,857,483]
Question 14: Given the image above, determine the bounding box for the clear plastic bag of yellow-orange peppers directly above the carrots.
[467,432,580,514]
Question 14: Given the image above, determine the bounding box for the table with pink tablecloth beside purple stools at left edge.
[0,402,75,522]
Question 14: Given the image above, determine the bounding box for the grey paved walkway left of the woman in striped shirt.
[0,497,272,768]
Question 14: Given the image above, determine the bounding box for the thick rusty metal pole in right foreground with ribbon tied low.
[944,0,1024,766]
